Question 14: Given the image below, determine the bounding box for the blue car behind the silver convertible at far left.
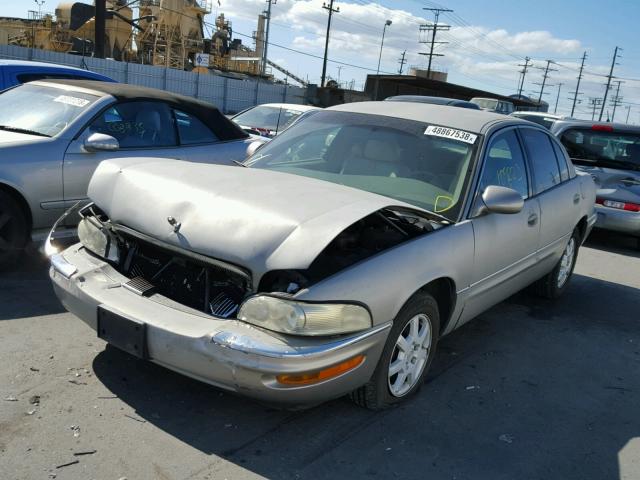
[0,60,115,90]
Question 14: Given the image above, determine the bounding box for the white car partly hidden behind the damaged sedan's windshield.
[231,103,320,138]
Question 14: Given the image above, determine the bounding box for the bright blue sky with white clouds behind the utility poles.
[5,0,640,123]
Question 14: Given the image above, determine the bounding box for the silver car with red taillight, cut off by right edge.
[552,120,640,248]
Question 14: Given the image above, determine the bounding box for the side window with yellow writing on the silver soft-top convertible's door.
[89,102,177,149]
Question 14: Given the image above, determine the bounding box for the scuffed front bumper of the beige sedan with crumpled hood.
[50,244,391,407]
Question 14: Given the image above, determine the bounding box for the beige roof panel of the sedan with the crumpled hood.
[326,101,531,133]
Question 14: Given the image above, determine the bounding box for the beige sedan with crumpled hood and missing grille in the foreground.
[51,102,595,409]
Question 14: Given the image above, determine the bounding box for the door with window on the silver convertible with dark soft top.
[63,101,184,203]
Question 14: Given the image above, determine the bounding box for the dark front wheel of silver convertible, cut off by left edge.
[0,190,29,269]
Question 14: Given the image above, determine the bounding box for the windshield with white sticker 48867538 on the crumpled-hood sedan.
[249,111,477,221]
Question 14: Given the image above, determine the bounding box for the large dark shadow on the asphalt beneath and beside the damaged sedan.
[93,275,640,479]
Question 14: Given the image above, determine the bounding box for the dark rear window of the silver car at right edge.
[560,128,640,170]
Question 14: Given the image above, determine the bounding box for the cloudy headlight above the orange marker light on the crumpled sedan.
[238,295,371,336]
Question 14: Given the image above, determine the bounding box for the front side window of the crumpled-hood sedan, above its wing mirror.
[480,130,529,199]
